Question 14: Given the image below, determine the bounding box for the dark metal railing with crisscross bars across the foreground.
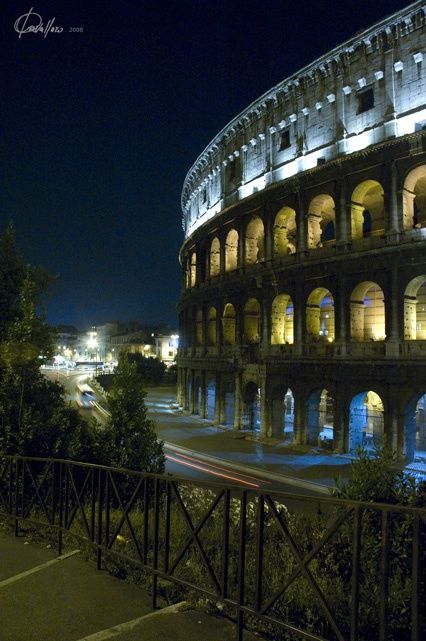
[0,457,426,641]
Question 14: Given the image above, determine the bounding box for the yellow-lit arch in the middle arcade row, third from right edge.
[306,287,334,343]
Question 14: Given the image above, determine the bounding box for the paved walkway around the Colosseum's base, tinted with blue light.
[147,386,351,491]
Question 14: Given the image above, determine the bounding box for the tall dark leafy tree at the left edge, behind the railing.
[0,226,96,460]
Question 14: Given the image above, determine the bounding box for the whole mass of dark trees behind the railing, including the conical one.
[0,225,164,472]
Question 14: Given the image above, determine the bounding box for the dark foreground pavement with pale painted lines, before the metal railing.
[0,532,259,641]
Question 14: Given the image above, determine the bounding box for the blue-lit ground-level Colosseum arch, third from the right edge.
[307,389,335,449]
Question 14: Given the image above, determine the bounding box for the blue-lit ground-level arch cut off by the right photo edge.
[404,394,426,462]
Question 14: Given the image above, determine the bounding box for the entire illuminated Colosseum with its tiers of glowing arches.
[178,2,426,469]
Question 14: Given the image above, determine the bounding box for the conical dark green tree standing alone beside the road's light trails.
[103,354,165,473]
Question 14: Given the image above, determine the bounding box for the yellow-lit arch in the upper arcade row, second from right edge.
[351,180,385,240]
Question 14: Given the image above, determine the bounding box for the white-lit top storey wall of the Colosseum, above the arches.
[182,2,426,236]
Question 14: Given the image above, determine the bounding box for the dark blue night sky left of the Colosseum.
[0,0,408,329]
